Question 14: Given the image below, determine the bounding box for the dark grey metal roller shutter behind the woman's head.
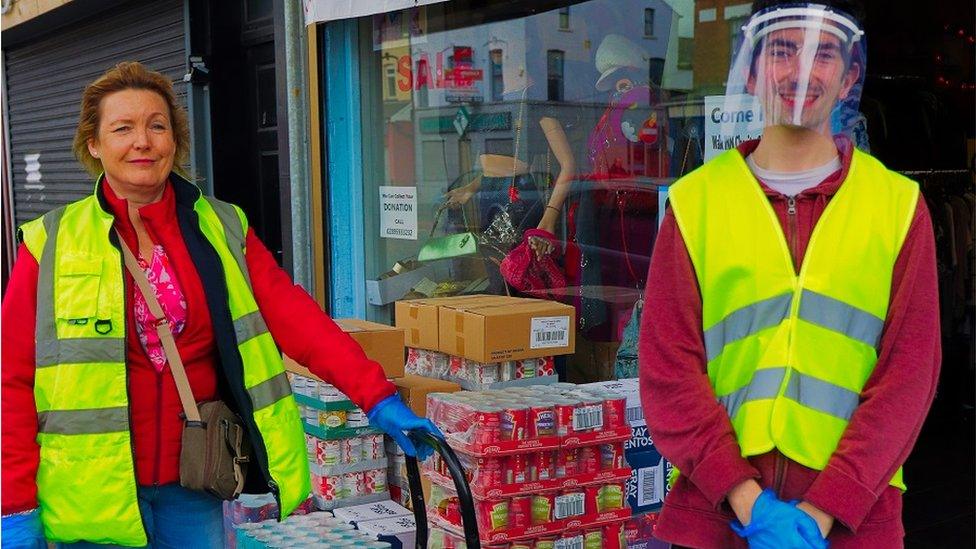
[4,0,186,225]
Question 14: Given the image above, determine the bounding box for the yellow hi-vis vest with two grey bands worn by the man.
[669,150,919,490]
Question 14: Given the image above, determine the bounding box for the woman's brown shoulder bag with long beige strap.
[119,235,251,500]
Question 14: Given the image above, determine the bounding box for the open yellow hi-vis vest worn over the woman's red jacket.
[21,174,311,546]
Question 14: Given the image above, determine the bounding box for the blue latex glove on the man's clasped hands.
[732,488,829,549]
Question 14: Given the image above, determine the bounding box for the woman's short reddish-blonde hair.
[71,61,190,176]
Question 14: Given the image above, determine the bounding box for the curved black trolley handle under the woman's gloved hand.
[407,430,481,549]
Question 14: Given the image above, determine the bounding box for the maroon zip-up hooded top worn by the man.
[639,140,941,549]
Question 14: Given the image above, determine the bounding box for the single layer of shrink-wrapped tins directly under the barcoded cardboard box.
[405,348,558,391]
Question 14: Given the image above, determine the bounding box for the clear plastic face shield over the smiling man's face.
[723,4,865,135]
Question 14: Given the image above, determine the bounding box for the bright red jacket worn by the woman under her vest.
[0,181,395,514]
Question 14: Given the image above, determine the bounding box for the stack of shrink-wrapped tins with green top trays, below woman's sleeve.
[289,373,390,510]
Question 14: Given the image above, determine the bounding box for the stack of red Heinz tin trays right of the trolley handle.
[424,383,631,548]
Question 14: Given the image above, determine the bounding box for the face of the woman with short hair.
[88,89,176,194]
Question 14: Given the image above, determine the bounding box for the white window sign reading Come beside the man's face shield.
[704,94,763,162]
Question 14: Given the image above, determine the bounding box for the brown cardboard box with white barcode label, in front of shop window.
[438,297,576,362]
